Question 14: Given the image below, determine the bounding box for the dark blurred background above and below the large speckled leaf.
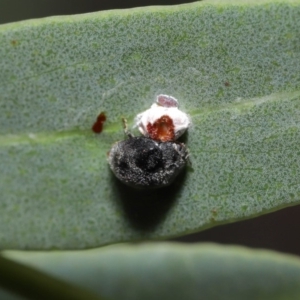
[0,0,300,255]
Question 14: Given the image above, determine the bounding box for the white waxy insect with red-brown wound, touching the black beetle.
[135,95,191,142]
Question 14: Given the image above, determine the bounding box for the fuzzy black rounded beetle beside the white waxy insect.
[108,119,189,189]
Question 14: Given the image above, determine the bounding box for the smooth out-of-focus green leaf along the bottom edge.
[5,243,300,300]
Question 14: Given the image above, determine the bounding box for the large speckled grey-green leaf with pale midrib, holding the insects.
[0,0,300,249]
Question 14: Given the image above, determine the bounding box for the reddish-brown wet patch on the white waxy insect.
[147,116,175,142]
